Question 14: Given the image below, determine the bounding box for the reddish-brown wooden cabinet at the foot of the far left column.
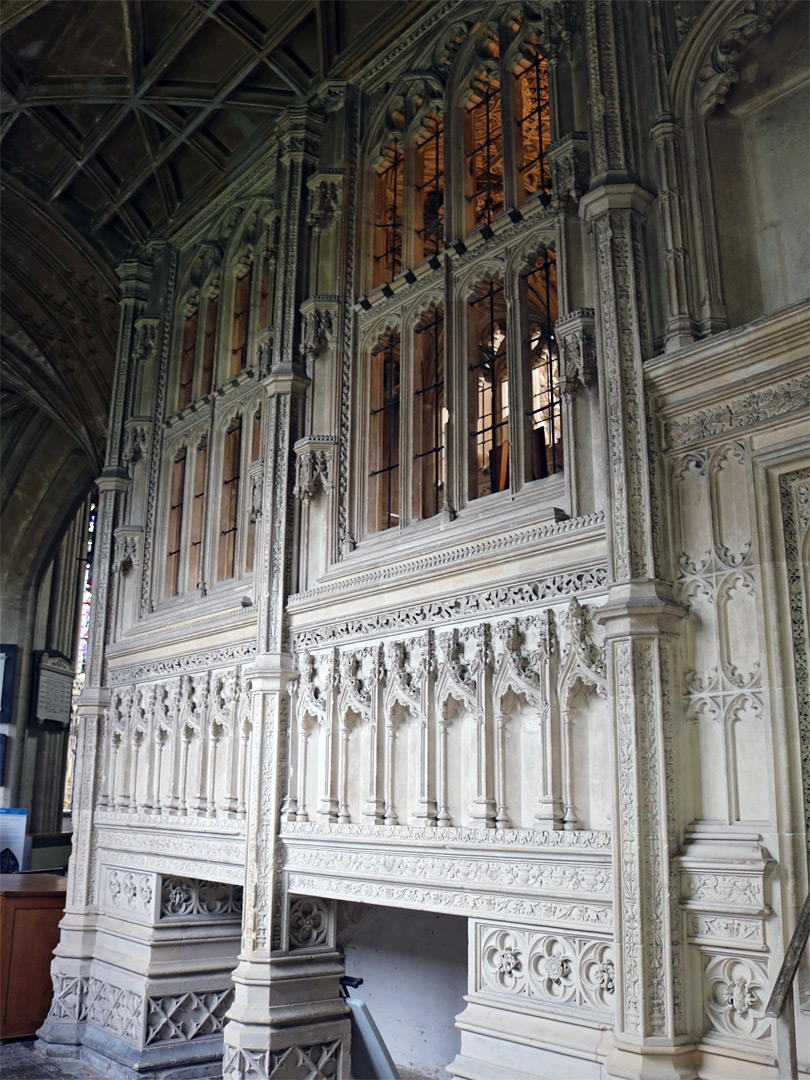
[0,874,67,1039]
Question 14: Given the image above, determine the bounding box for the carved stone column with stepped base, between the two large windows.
[222,107,349,1080]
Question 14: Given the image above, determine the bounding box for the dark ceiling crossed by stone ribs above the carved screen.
[0,0,426,259]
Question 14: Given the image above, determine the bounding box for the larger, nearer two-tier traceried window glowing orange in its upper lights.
[359,17,564,532]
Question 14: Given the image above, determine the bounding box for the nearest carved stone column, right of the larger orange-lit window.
[580,0,696,1078]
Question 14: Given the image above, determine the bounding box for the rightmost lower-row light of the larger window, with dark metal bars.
[524,252,563,480]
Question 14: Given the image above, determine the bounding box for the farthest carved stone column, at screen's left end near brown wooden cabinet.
[39,258,151,1047]
